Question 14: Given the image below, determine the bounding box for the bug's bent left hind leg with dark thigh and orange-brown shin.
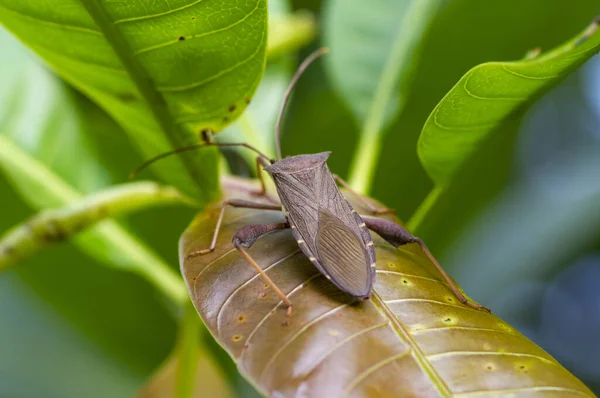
[233,223,292,316]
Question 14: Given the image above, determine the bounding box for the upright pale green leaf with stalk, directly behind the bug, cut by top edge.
[325,0,442,192]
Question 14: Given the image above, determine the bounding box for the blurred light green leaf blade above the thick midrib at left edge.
[0,29,134,193]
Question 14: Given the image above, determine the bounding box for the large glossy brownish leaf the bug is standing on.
[180,182,593,398]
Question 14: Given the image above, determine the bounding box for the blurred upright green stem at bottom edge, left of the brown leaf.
[174,302,201,398]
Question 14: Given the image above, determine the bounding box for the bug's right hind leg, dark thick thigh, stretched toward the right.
[363,217,490,312]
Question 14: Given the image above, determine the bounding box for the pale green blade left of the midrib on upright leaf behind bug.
[323,0,411,124]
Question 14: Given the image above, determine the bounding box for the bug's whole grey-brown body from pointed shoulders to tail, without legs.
[265,152,375,298]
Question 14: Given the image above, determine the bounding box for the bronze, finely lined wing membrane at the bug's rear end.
[316,208,373,297]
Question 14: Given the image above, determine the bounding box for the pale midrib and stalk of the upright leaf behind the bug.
[349,0,443,194]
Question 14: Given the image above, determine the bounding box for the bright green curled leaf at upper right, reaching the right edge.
[419,19,600,186]
